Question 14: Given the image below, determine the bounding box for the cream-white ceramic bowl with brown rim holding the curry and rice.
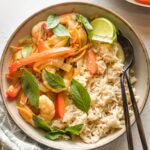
[0,2,150,150]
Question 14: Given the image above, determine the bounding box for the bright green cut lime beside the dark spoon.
[89,18,117,43]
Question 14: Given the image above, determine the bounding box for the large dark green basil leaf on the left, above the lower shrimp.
[21,69,40,107]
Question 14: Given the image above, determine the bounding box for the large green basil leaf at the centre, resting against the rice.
[70,79,91,113]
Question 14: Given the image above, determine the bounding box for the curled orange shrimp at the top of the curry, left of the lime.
[60,13,87,47]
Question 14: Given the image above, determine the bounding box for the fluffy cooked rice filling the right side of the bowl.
[52,42,139,143]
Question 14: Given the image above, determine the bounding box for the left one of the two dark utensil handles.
[120,73,134,150]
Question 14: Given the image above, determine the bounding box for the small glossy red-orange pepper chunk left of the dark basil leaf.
[6,82,21,99]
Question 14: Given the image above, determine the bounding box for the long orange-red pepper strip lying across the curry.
[9,47,74,72]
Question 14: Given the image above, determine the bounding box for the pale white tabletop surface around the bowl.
[0,0,150,150]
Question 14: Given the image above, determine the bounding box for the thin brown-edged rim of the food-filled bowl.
[0,0,150,150]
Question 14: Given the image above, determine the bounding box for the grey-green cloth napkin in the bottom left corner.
[0,98,52,150]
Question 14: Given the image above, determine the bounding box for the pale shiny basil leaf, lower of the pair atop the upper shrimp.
[53,24,70,37]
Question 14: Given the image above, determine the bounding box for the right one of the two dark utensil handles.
[125,72,148,150]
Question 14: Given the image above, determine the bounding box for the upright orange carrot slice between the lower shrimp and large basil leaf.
[55,92,65,120]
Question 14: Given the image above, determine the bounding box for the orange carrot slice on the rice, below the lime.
[86,49,98,75]
